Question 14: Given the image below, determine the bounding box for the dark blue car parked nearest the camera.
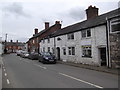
[38,52,56,64]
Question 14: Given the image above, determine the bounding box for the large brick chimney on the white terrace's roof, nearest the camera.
[86,5,98,20]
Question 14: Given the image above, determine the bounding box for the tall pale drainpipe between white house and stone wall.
[106,17,112,68]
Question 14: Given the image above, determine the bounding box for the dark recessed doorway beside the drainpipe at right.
[99,48,107,66]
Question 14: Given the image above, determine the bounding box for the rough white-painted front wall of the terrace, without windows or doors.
[40,25,106,66]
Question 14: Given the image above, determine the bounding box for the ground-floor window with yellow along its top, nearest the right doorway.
[82,46,92,57]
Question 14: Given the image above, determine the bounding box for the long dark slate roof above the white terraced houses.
[52,8,120,37]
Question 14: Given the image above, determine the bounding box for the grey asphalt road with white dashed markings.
[2,54,118,88]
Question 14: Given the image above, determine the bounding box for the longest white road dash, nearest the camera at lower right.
[59,73,103,89]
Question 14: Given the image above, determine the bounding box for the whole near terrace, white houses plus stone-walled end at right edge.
[39,6,120,68]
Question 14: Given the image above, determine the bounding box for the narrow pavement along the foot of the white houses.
[57,60,120,76]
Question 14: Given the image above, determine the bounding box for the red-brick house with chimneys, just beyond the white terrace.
[27,21,61,53]
